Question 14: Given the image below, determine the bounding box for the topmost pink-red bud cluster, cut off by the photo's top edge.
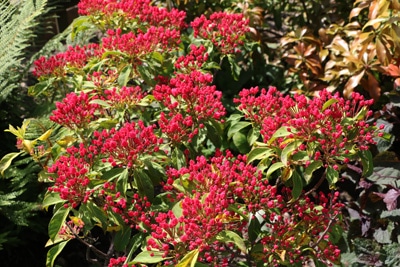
[78,0,186,30]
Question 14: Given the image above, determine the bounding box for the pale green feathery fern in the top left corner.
[0,0,47,103]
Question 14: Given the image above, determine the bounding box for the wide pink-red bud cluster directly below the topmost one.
[102,26,180,59]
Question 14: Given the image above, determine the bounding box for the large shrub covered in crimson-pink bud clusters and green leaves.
[2,0,379,267]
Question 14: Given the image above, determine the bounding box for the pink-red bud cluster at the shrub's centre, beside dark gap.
[153,71,225,142]
